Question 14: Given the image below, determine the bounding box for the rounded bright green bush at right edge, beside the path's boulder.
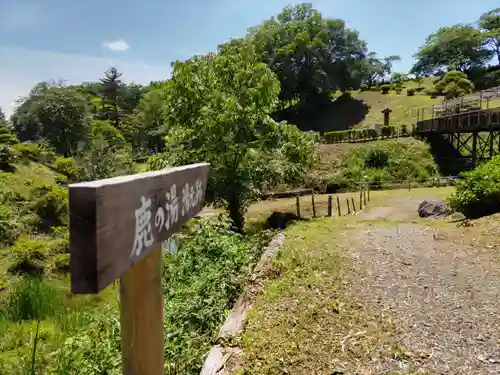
[448,155,500,218]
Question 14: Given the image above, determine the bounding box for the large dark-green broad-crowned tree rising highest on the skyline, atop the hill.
[248,3,366,106]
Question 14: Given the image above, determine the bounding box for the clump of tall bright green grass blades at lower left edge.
[1,277,62,321]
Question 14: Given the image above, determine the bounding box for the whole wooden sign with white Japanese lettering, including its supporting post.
[69,164,209,375]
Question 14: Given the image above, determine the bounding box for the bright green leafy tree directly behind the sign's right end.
[149,40,315,231]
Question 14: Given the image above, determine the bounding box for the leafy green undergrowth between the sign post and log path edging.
[164,218,266,374]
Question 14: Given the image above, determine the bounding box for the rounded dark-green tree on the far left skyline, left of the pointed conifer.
[11,82,91,156]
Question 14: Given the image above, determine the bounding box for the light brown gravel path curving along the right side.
[351,200,500,375]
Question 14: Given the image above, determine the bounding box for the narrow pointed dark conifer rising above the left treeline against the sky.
[98,67,124,129]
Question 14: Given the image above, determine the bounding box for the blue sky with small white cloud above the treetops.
[0,0,499,114]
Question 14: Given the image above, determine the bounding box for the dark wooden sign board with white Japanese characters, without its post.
[69,164,209,293]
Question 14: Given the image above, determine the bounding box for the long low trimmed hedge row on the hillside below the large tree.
[325,124,410,143]
